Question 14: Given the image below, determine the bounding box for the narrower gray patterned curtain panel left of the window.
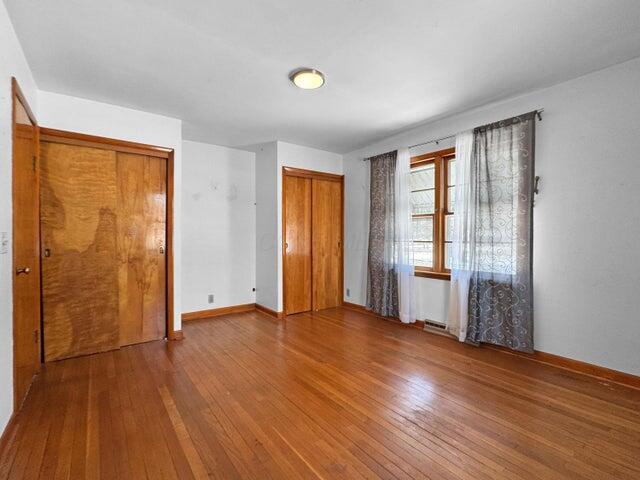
[367,152,399,317]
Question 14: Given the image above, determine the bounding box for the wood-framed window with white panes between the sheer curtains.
[411,148,456,279]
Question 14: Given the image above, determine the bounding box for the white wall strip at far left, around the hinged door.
[0,2,38,432]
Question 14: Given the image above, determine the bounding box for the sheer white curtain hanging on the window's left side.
[394,148,416,323]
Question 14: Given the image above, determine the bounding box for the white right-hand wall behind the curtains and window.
[345,59,640,375]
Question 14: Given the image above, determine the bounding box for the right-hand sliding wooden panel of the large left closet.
[117,153,167,345]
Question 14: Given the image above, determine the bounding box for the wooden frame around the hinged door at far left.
[10,77,42,412]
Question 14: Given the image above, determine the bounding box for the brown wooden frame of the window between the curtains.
[411,148,456,280]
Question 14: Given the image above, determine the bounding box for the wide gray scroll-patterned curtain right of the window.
[467,112,535,352]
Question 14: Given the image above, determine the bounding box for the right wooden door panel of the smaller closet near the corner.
[312,178,342,310]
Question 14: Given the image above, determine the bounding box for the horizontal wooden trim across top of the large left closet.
[40,127,173,159]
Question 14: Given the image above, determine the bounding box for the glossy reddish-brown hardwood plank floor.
[0,308,640,480]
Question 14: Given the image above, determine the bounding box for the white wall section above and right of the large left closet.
[38,91,182,330]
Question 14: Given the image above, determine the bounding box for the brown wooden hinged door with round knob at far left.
[12,80,40,410]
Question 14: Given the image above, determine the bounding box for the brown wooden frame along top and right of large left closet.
[40,127,183,340]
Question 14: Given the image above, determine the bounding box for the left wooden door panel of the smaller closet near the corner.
[282,175,311,315]
